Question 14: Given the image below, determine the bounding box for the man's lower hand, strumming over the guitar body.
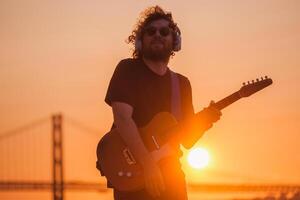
[142,156,165,197]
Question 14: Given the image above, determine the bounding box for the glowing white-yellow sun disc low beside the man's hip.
[187,148,210,169]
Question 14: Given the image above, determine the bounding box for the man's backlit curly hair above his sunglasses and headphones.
[126,5,180,58]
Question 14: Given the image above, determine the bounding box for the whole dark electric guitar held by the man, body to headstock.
[97,76,273,191]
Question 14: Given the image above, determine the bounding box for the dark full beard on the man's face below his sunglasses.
[142,39,173,61]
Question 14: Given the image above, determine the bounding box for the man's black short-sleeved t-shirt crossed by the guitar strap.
[105,59,194,127]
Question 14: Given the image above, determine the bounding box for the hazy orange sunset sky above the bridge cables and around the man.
[0,0,300,189]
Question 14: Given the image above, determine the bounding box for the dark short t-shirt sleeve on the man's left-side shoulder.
[105,60,135,107]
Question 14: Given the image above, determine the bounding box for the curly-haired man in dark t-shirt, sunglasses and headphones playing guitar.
[105,6,221,200]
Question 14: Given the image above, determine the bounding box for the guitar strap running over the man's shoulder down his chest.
[170,70,182,121]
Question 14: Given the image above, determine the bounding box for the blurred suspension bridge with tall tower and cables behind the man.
[0,114,300,200]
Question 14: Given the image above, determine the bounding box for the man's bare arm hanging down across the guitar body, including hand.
[112,102,164,196]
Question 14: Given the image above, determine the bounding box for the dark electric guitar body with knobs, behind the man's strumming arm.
[97,112,177,191]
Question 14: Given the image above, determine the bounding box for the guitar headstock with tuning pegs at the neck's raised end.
[239,76,273,97]
